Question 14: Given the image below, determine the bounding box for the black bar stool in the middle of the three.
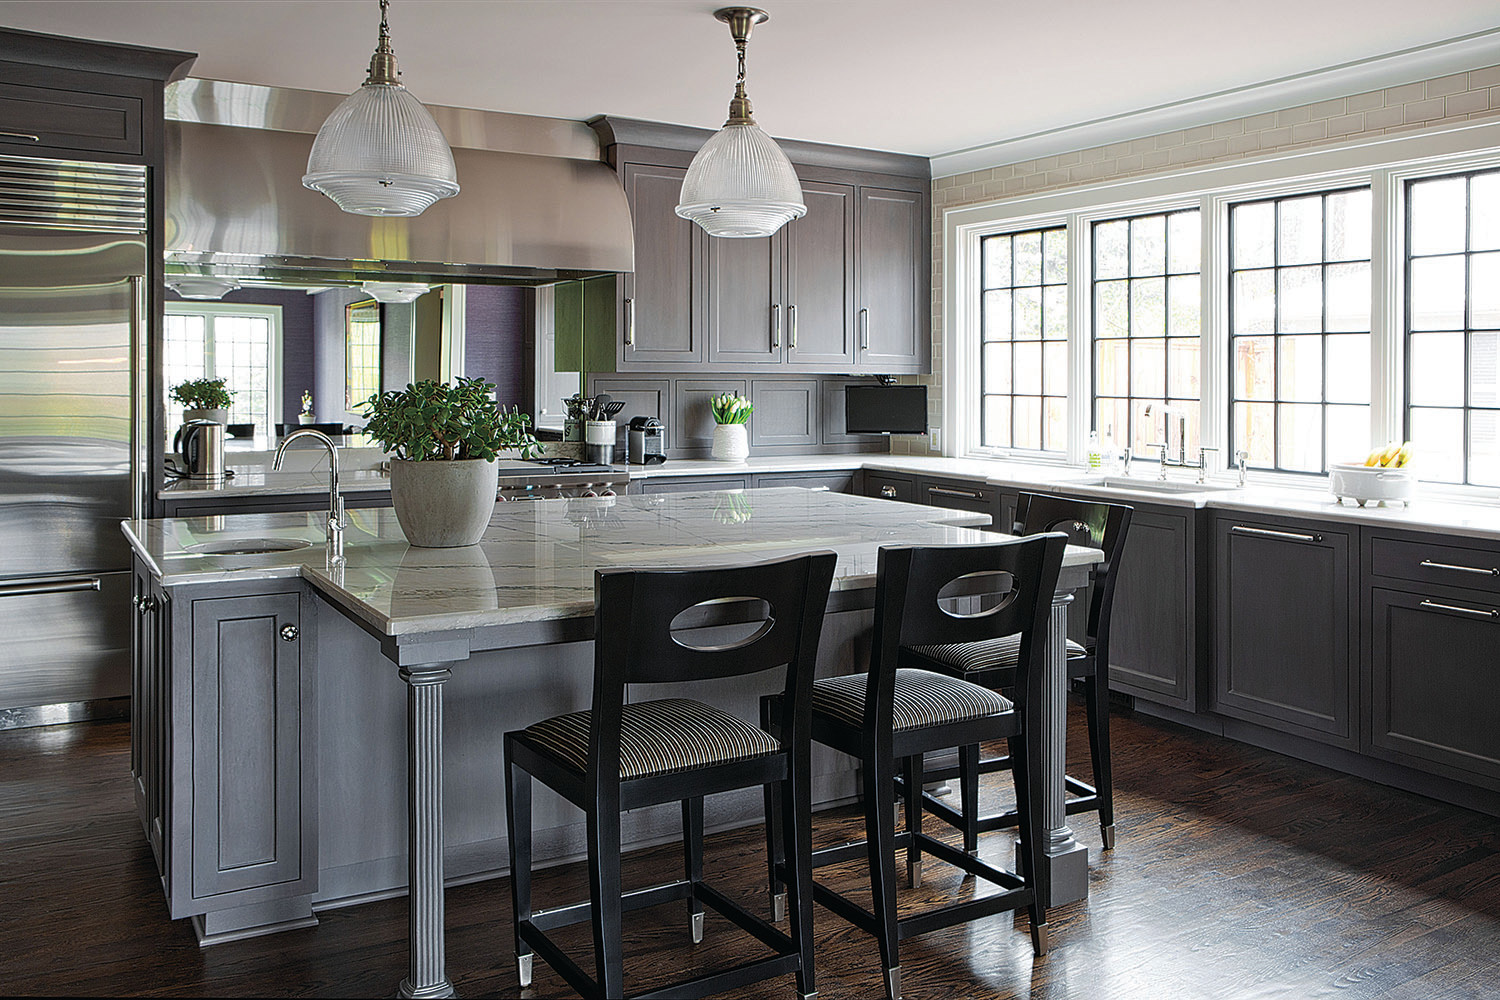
[761,534,1067,1000]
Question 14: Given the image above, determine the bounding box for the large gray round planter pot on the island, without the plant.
[390,459,500,549]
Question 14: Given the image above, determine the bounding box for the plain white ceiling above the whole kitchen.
[0,0,1500,156]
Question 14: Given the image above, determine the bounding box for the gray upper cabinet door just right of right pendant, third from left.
[785,181,855,370]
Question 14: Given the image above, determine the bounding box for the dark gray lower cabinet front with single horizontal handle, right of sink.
[1212,514,1359,750]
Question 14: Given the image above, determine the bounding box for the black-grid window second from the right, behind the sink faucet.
[1229,187,1371,472]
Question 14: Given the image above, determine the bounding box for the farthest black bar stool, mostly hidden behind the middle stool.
[902,493,1133,852]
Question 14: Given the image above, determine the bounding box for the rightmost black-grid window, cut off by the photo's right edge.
[1406,171,1500,486]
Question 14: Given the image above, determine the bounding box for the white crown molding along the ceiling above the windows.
[932,28,1500,178]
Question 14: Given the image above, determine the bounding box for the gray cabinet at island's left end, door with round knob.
[132,565,318,930]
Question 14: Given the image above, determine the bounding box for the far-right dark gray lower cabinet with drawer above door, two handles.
[1365,531,1500,789]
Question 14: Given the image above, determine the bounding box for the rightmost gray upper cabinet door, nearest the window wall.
[857,187,932,372]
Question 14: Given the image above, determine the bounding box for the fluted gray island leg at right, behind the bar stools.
[1040,592,1089,907]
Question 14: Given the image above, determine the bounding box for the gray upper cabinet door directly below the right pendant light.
[704,235,786,364]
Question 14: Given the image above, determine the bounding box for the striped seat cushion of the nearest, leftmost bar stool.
[521,699,782,778]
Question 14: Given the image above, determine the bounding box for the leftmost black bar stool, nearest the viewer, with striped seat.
[506,552,836,1000]
